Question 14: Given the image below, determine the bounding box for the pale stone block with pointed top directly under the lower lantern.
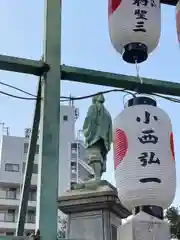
[120,212,171,240]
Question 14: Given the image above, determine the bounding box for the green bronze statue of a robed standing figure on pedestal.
[83,94,112,179]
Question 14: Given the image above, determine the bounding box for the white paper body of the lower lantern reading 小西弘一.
[113,105,176,210]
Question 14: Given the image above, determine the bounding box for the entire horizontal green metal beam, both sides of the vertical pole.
[0,55,180,96]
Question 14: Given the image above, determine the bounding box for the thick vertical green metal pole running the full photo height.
[36,0,61,240]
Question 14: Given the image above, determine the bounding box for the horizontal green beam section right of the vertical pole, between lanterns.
[61,65,180,96]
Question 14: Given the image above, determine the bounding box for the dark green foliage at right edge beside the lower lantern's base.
[165,207,180,239]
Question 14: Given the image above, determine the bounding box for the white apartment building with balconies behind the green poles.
[0,106,93,235]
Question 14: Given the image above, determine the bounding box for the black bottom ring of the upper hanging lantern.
[122,42,148,64]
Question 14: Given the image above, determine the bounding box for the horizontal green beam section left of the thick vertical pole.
[0,55,49,76]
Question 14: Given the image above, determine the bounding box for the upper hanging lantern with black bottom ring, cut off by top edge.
[108,0,161,63]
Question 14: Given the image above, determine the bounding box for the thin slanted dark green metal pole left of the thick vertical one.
[16,80,41,236]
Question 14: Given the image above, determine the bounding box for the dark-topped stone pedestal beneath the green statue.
[59,181,130,240]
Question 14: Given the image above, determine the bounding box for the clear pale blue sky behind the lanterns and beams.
[0,0,180,206]
